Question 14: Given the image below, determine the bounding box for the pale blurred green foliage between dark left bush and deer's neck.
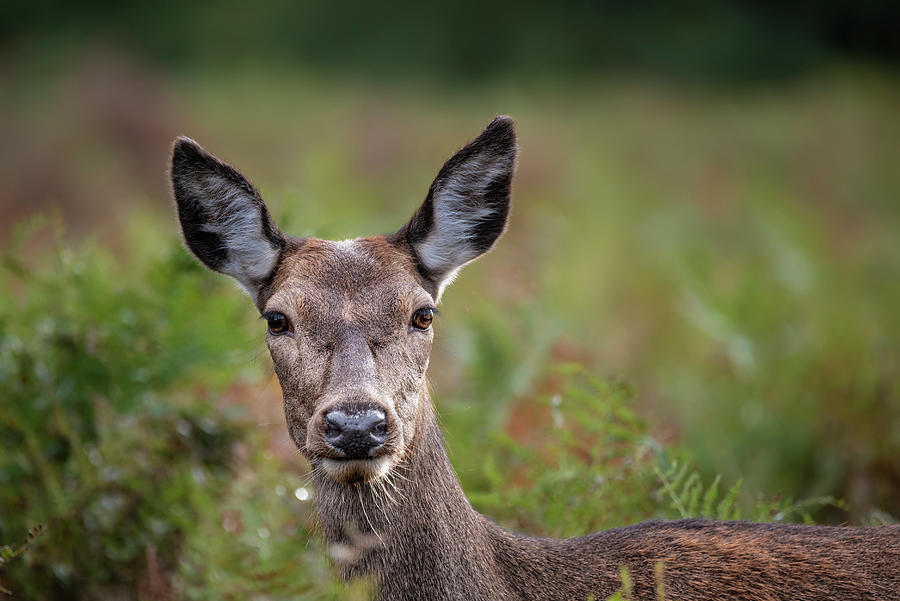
[176,436,362,601]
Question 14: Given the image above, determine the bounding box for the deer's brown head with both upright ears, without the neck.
[171,117,516,483]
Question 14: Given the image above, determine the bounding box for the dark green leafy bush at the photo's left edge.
[0,223,262,599]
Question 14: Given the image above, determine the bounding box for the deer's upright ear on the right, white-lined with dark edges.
[398,116,516,298]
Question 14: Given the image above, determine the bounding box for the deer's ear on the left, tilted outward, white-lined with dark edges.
[171,137,286,301]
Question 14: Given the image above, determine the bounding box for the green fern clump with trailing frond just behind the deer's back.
[467,365,846,536]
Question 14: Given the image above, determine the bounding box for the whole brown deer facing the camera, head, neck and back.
[170,116,900,601]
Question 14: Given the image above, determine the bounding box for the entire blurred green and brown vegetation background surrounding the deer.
[0,0,900,599]
